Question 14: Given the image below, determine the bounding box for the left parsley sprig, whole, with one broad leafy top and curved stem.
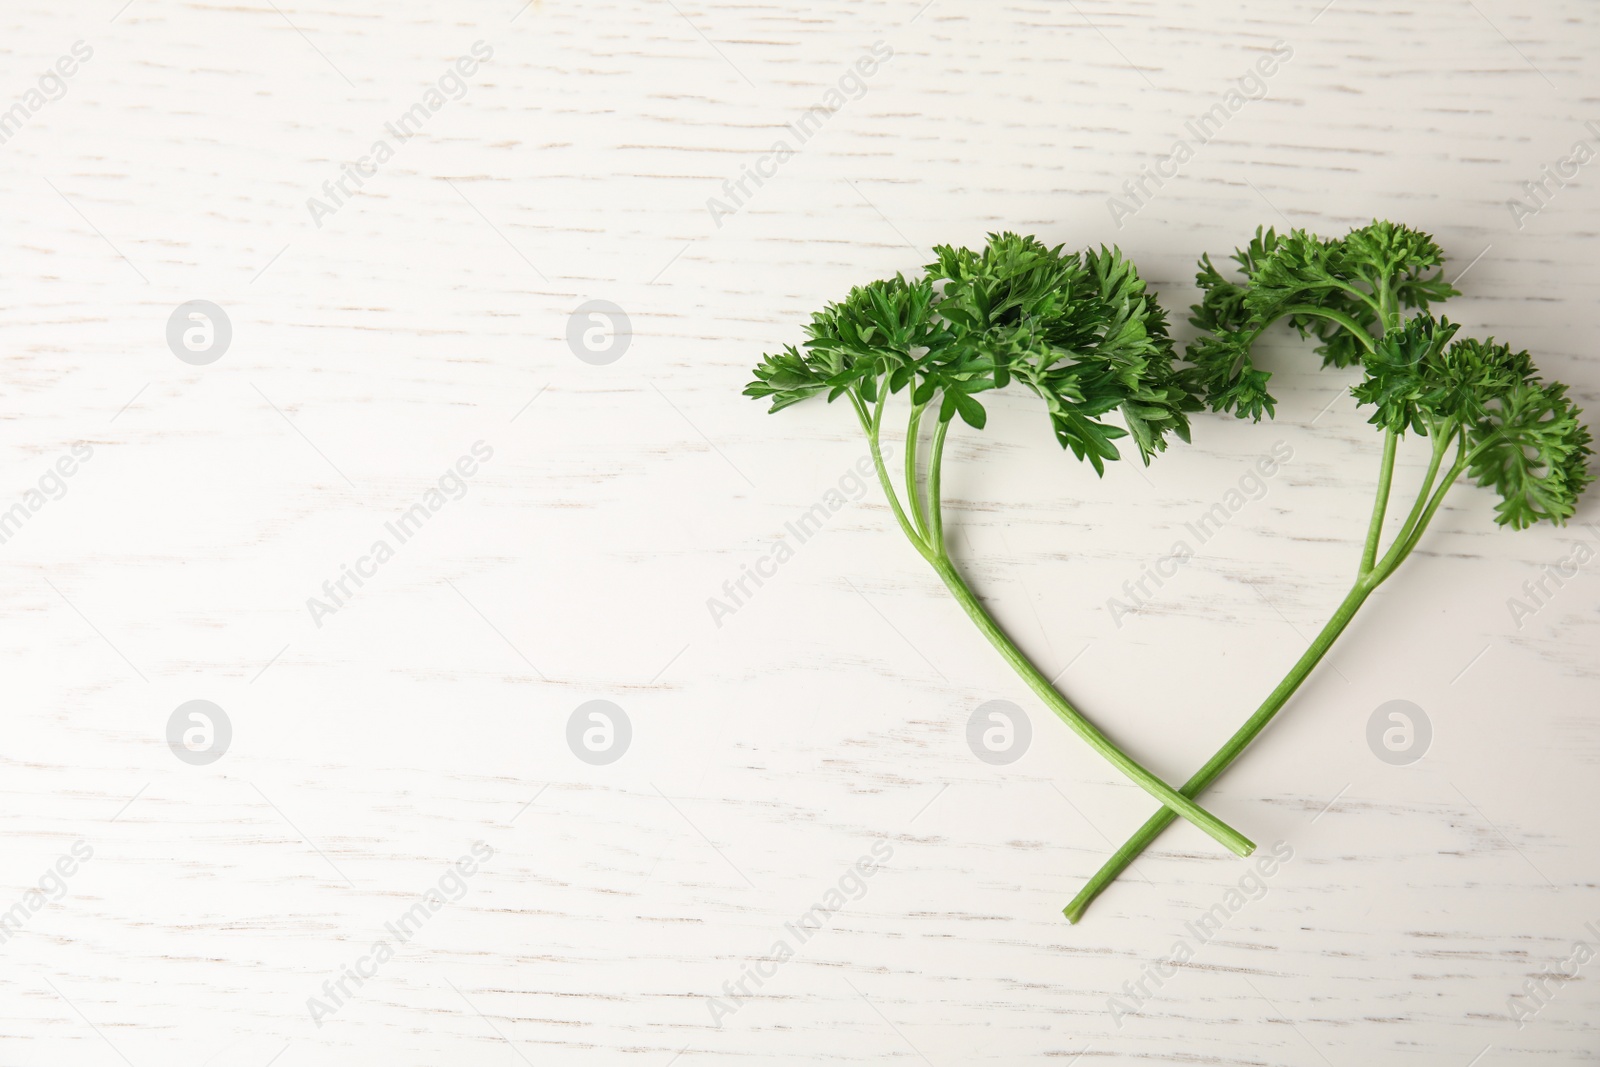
[744,234,1254,856]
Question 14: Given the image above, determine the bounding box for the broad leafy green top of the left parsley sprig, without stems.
[744,234,1200,474]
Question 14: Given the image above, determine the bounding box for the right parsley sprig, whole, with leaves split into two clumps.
[1066,221,1594,921]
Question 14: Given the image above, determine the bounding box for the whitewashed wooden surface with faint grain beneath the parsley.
[0,0,1600,1067]
